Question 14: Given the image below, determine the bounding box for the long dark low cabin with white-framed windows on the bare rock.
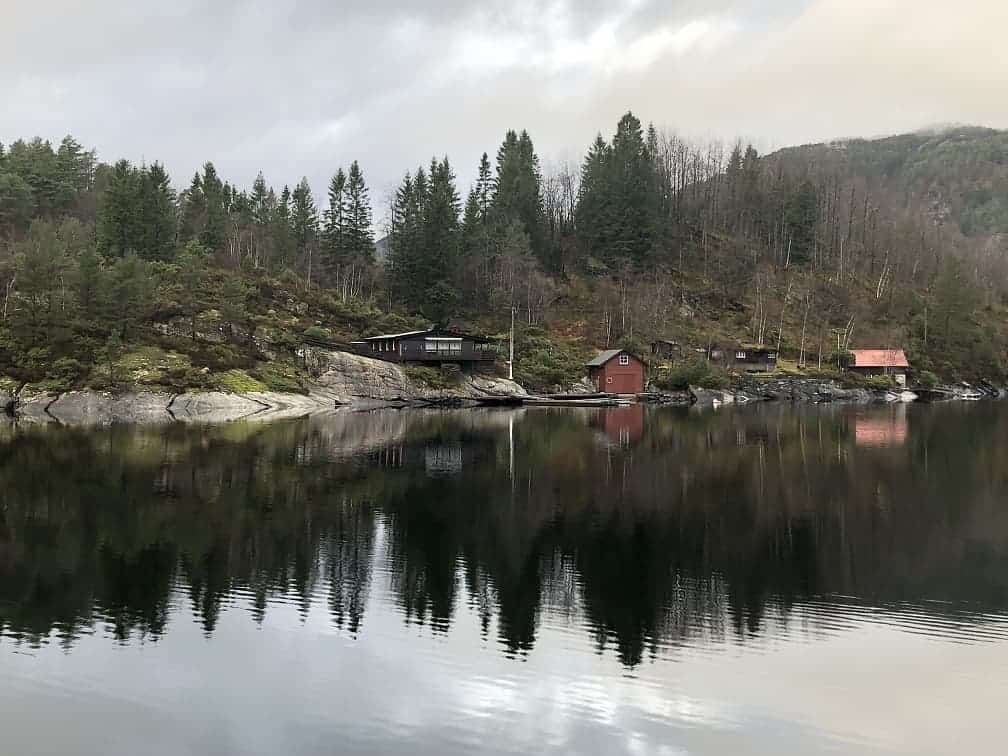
[354,329,497,369]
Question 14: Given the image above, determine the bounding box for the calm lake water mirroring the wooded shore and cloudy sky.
[0,403,1008,756]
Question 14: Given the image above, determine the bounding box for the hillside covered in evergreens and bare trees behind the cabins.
[0,118,1008,397]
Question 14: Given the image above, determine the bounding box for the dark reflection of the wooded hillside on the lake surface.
[0,405,1008,664]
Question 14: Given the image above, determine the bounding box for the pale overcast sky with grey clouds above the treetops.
[0,0,1008,204]
